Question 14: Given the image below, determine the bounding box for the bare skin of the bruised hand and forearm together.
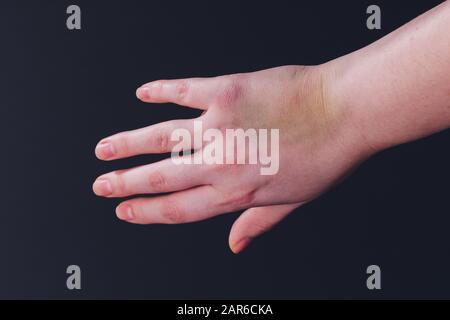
[93,1,450,253]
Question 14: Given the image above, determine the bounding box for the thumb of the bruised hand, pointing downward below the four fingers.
[228,203,303,254]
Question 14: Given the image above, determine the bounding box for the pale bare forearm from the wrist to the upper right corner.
[326,1,450,151]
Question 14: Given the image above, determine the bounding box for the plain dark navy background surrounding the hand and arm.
[0,0,450,299]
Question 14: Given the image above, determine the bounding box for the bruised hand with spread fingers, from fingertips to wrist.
[93,65,370,253]
